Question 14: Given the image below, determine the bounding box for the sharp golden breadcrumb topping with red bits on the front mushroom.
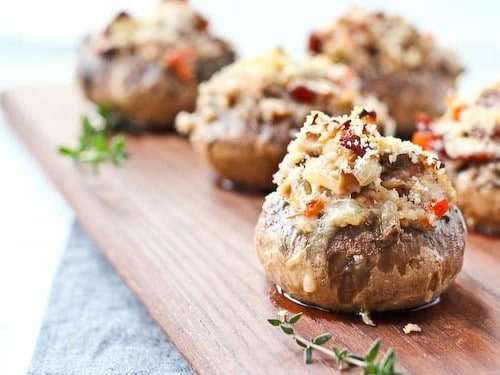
[265,107,455,232]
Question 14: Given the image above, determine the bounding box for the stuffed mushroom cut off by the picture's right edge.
[413,82,500,234]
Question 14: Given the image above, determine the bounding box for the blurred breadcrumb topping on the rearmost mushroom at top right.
[309,7,463,82]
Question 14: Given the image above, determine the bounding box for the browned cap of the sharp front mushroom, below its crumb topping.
[255,201,466,312]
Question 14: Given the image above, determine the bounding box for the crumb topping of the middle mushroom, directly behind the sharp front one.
[176,48,395,138]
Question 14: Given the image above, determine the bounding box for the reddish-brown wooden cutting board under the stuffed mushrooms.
[2,87,500,374]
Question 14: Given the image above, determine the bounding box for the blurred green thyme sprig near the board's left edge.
[58,105,128,173]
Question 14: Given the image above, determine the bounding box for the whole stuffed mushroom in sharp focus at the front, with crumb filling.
[255,108,466,312]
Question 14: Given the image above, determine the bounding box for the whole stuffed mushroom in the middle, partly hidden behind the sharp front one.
[176,49,394,191]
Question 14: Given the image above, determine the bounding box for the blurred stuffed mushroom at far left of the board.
[77,0,234,129]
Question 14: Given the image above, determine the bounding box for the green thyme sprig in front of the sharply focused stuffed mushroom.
[267,312,399,375]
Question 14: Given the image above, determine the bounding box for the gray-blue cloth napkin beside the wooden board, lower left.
[28,223,191,375]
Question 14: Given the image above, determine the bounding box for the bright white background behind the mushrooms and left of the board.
[0,0,500,374]
